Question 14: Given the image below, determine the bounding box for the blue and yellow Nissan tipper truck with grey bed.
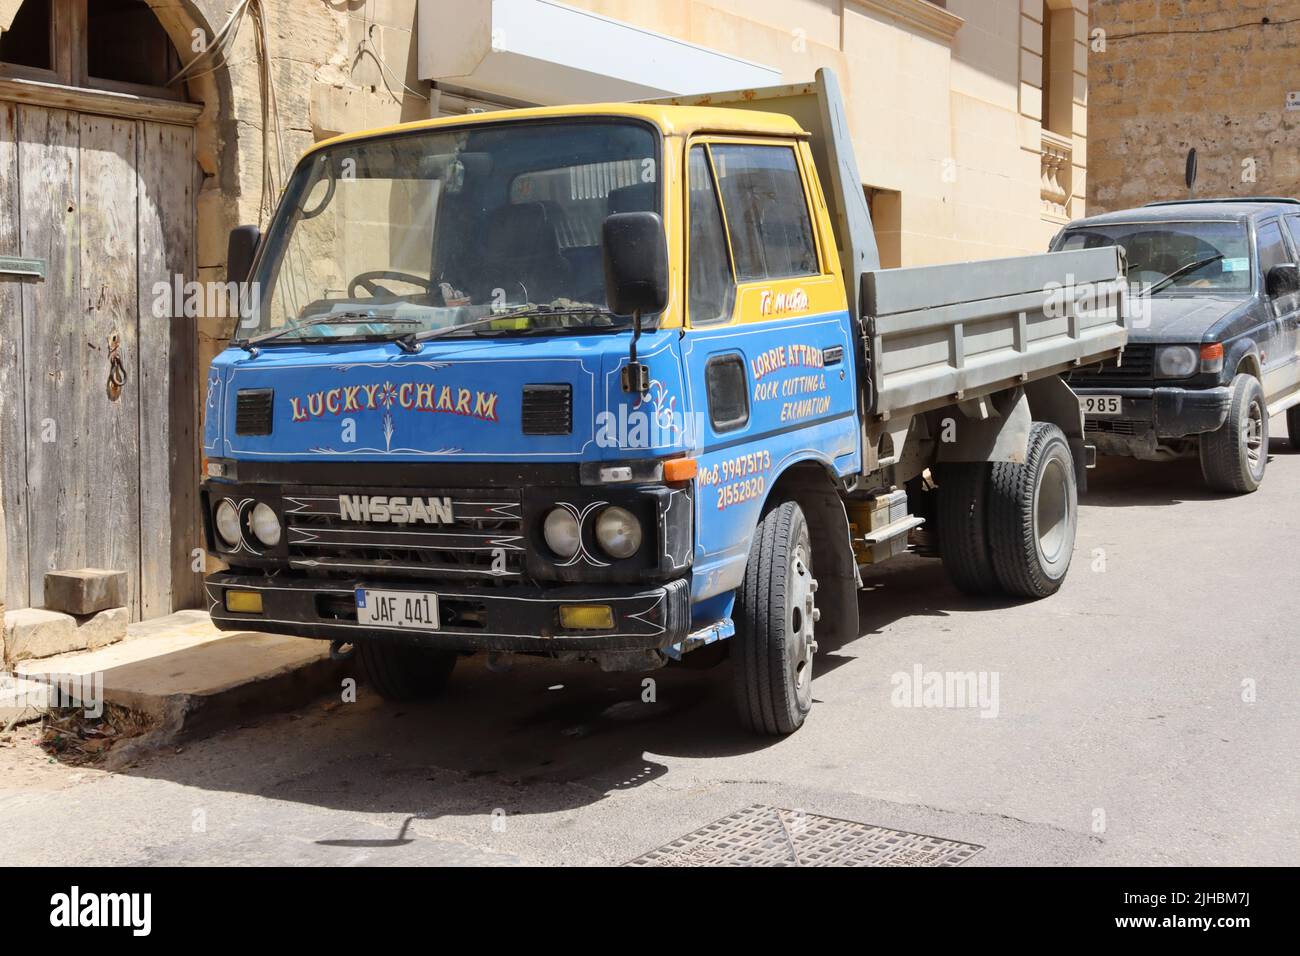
[203,72,1126,734]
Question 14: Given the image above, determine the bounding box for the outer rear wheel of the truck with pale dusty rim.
[988,421,1079,598]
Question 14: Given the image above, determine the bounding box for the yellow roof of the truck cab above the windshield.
[307,103,805,155]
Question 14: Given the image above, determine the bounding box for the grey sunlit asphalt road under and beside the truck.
[0,420,1300,865]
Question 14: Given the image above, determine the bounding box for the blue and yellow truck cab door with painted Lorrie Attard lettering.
[683,137,859,601]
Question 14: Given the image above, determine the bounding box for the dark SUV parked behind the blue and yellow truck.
[1052,198,1300,493]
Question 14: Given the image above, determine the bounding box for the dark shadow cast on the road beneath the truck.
[96,557,1000,832]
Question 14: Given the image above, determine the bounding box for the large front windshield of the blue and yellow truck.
[237,120,660,343]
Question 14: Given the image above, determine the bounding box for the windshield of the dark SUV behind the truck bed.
[1060,221,1252,295]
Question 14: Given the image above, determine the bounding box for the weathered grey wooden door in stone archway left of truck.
[0,103,199,618]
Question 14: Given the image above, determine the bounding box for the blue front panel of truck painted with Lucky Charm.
[203,332,685,462]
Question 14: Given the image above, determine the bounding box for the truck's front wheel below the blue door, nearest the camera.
[731,501,820,736]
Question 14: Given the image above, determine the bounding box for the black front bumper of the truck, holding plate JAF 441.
[204,571,690,652]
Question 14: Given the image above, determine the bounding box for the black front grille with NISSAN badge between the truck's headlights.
[283,485,527,581]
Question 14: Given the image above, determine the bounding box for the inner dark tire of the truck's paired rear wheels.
[935,462,1001,596]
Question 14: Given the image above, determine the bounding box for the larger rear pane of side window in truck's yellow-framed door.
[711,143,820,282]
